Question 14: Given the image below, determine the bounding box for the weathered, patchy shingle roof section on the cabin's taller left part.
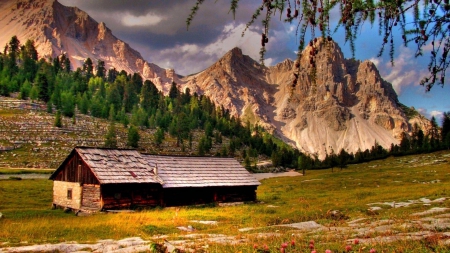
[75,148,161,184]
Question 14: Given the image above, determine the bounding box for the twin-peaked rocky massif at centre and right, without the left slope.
[182,39,420,158]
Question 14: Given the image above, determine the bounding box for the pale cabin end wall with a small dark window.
[53,181,82,210]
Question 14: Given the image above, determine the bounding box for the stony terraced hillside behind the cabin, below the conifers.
[0,97,228,168]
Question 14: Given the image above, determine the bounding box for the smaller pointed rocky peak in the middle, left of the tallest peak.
[181,48,276,128]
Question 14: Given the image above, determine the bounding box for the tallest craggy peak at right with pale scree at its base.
[275,39,410,157]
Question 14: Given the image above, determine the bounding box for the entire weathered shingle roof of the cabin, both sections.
[50,147,260,188]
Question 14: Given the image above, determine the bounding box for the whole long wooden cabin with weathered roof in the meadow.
[50,147,260,211]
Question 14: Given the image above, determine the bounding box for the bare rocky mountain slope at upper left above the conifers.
[0,0,179,92]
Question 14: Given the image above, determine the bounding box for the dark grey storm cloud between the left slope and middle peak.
[56,0,294,75]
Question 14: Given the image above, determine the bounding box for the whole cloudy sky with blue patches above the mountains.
[59,0,450,123]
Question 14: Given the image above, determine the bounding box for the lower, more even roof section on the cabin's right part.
[144,155,260,188]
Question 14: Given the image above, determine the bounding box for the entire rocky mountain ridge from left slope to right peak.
[0,0,429,158]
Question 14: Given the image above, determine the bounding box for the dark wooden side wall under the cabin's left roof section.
[101,184,162,209]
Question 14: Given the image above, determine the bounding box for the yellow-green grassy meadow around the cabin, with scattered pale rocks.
[0,151,450,252]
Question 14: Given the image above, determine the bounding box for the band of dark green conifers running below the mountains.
[0,36,450,173]
